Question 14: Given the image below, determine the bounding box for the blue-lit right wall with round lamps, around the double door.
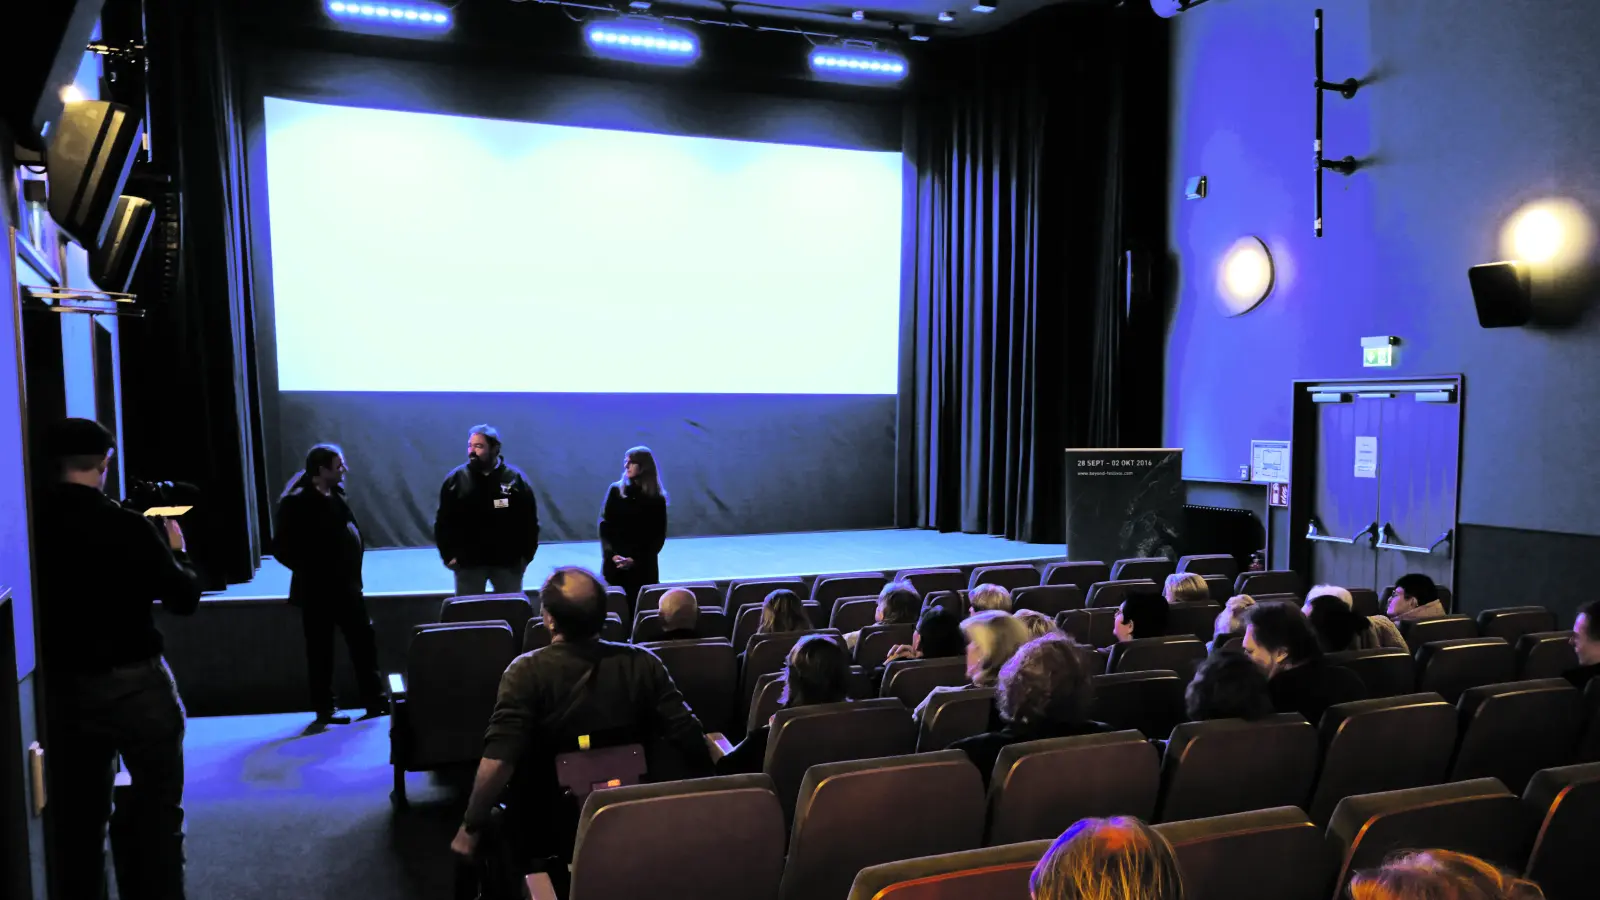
[1165,0,1600,608]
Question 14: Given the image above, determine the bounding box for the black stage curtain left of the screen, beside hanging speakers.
[123,0,267,586]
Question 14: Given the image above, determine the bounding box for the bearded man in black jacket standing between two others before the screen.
[434,424,539,596]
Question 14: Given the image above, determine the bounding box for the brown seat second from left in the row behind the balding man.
[778,749,984,900]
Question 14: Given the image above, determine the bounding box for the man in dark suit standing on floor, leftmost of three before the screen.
[275,444,389,727]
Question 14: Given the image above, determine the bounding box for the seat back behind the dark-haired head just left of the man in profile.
[1160,713,1318,822]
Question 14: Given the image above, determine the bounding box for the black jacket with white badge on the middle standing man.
[434,458,539,567]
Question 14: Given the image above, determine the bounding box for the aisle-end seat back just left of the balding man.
[405,621,517,770]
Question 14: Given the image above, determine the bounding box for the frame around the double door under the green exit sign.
[1290,373,1467,596]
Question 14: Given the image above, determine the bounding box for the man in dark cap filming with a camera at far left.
[34,418,202,900]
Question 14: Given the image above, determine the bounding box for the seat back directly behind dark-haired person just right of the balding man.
[762,698,921,820]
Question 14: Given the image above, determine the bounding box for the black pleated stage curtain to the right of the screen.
[901,5,1166,541]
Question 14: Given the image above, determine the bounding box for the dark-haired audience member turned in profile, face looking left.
[1245,604,1366,725]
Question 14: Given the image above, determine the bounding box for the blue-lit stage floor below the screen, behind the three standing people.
[206,528,1067,601]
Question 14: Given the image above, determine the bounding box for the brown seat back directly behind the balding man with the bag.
[568,775,787,900]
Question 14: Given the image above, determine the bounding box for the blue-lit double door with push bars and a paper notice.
[1291,376,1462,591]
